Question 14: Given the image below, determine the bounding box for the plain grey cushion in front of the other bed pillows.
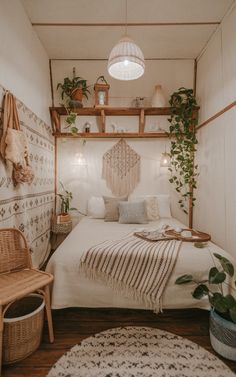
[119,200,148,224]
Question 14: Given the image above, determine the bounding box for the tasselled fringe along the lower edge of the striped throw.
[79,262,162,314]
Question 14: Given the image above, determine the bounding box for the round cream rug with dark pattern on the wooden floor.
[47,327,235,377]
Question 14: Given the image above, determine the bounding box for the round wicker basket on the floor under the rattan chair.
[3,294,45,364]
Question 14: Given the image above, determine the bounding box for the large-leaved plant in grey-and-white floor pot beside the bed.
[175,248,236,361]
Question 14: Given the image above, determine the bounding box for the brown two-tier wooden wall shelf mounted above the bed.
[49,106,199,138]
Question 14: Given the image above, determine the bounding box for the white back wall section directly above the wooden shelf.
[52,60,194,106]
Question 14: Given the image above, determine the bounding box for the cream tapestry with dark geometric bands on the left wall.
[0,86,54,266]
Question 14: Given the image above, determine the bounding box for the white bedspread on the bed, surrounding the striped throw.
[47,217,232,309]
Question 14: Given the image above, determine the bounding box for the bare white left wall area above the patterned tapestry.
[0,0,51,123]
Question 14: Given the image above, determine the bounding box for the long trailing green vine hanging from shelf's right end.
[168,88,198,213]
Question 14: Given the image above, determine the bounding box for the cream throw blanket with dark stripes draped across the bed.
[80,235,181,312]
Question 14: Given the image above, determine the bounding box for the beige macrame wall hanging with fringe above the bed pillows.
[102,139,140,196]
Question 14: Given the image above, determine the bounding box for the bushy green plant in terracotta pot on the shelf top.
[57,76,90,108]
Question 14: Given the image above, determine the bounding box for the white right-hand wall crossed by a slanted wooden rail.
[194,3,236,257]
